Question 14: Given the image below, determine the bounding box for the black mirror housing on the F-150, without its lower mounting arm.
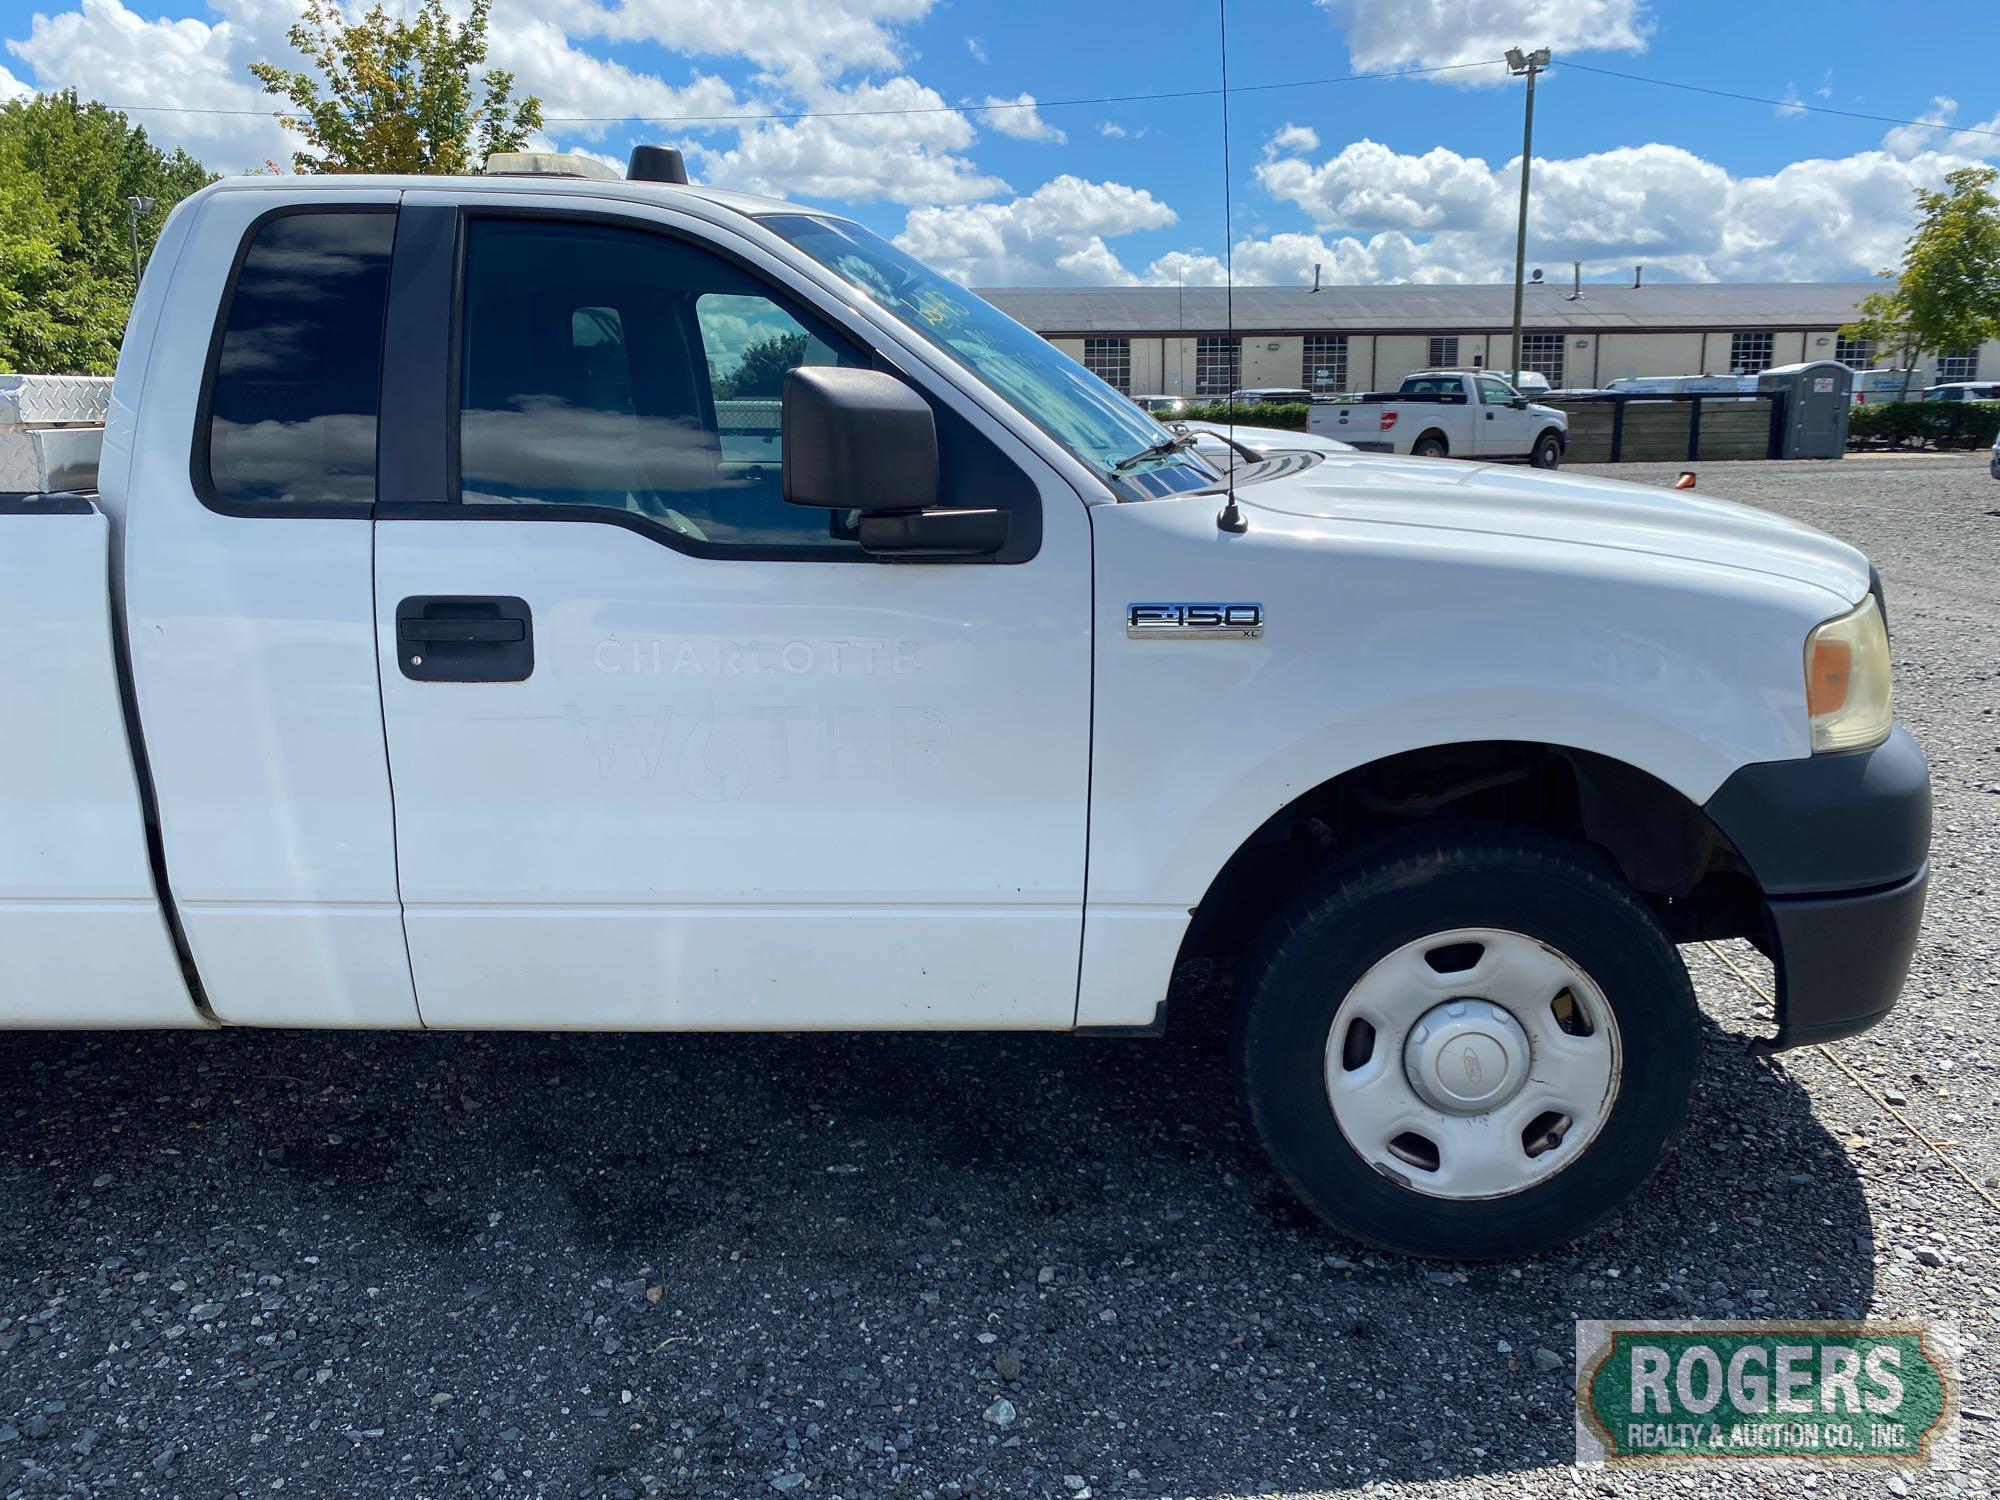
[780,364,938,510]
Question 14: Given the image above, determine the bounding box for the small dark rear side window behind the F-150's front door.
[208,212,396,504]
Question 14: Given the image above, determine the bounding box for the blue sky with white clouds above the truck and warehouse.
[0,0,2000,284]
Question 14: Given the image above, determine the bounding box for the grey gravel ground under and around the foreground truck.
[0,456,2000,1500]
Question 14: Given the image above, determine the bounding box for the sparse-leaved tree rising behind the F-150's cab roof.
[250,0,542,174]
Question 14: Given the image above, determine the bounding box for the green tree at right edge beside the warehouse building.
[1842,166,2000,396]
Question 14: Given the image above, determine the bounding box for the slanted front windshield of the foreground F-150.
[762,214,1220,496]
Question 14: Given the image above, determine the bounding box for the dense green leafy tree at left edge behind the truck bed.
[0,92,210,374]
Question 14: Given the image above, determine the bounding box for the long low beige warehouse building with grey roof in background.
[982,282,2000,396]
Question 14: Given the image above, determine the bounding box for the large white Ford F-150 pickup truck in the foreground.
[0,156,1930,1256]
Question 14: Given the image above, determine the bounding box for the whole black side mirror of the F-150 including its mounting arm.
[780,364,1008,558]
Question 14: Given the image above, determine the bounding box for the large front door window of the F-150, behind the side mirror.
[458,220,862,552]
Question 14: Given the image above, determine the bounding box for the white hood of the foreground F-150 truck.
[1236,452,1868,604]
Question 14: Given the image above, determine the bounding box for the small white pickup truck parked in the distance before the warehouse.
[1306,370,1570,468]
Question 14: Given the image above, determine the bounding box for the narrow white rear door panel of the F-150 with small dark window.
[118,186,418,1026]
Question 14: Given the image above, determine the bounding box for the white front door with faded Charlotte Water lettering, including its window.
[376,194,1090,1028]
